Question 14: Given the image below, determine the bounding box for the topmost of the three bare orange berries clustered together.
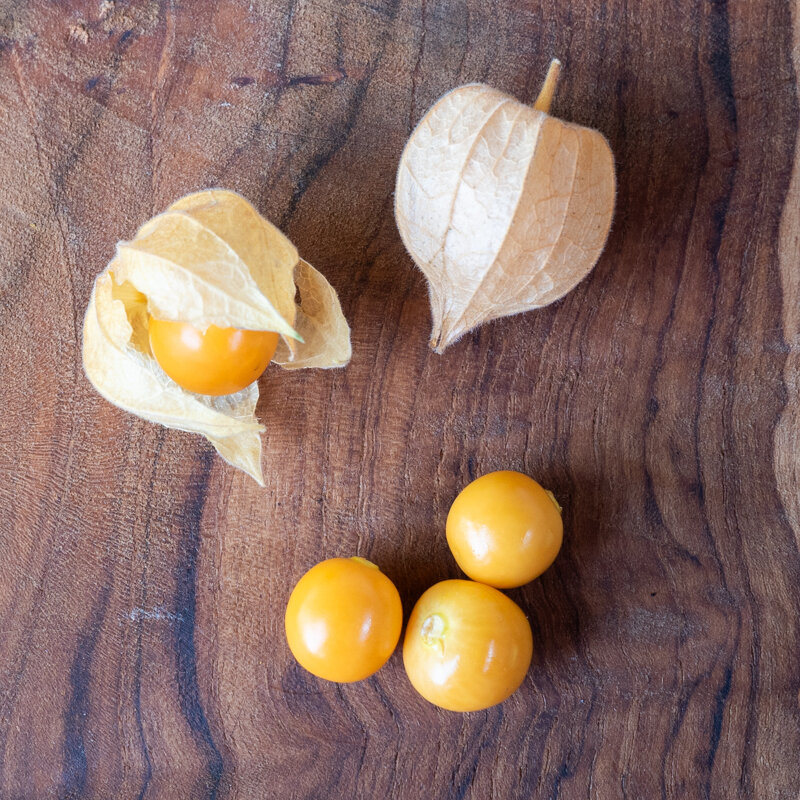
[446,470,564,589]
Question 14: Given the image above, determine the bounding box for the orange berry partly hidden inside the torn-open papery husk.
[150,317,278,395]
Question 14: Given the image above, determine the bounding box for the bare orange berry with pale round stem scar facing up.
[403,580,533,711]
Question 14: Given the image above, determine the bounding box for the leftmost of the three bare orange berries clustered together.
[285,557,403,683]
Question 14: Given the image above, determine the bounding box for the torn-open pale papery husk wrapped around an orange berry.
[83,189,351,486]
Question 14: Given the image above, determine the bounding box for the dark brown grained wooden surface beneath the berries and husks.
[0,0,800,800]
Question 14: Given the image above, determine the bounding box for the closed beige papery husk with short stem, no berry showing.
[395,61,615,352]
